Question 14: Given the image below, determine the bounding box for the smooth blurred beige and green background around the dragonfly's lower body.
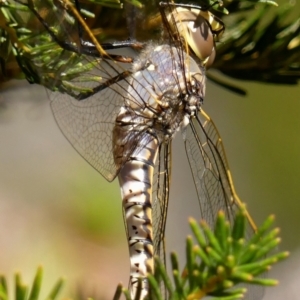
[0,77,300,299]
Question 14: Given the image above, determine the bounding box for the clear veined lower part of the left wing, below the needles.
[50,77,126,181]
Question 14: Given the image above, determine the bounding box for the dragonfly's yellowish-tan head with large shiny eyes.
[173,7,225,68]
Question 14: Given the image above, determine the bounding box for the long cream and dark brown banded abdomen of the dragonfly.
[118,138,158,299]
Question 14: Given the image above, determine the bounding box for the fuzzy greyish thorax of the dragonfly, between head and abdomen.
[113,45,205,142]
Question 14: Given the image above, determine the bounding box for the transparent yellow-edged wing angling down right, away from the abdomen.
[184,111,264,300]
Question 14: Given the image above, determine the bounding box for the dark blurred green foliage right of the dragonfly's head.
[214,3,300,84]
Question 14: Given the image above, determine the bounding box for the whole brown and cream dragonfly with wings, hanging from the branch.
[5,0,256,299]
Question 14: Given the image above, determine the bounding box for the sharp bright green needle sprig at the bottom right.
[116,208,289,300]
